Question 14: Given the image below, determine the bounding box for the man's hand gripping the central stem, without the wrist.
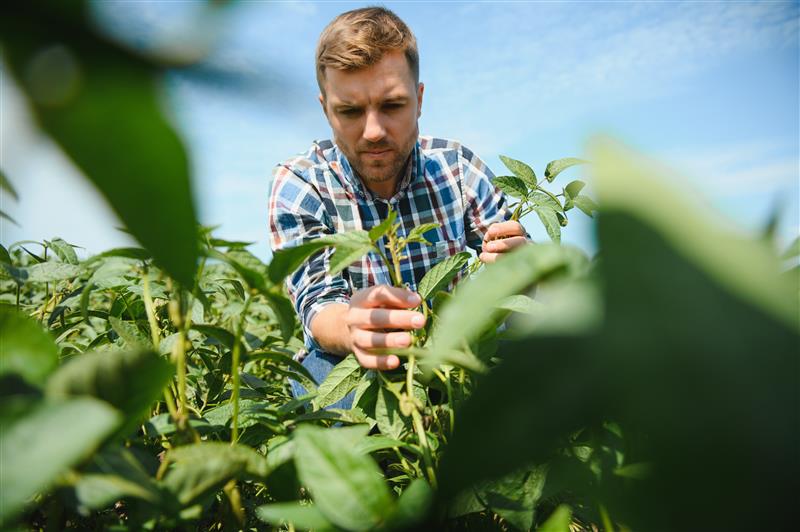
[344,284,425,370]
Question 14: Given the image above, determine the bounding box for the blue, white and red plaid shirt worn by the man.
[269,137,510,350]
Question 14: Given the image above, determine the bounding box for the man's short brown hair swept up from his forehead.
[317,7,419,94]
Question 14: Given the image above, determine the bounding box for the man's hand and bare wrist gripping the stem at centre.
[311,284,425,370]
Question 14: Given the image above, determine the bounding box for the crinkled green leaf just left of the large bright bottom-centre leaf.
[162,442,269,506]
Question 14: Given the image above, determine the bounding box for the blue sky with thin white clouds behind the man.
[0,0,800,257]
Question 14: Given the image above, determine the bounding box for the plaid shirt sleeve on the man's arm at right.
[459,142,511,248]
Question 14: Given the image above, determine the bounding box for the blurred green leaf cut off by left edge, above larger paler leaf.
[0,307,58,386]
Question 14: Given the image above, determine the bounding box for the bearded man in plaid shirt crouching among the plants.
[269,7,526,408]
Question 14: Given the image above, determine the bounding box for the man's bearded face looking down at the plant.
[320,51,424,195]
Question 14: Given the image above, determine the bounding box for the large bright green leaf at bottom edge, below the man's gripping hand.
[294,426,395,530]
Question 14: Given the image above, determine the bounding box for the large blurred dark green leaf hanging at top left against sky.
[2,12,197,286]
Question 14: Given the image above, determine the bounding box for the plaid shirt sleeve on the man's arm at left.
[269,165,351,349]
